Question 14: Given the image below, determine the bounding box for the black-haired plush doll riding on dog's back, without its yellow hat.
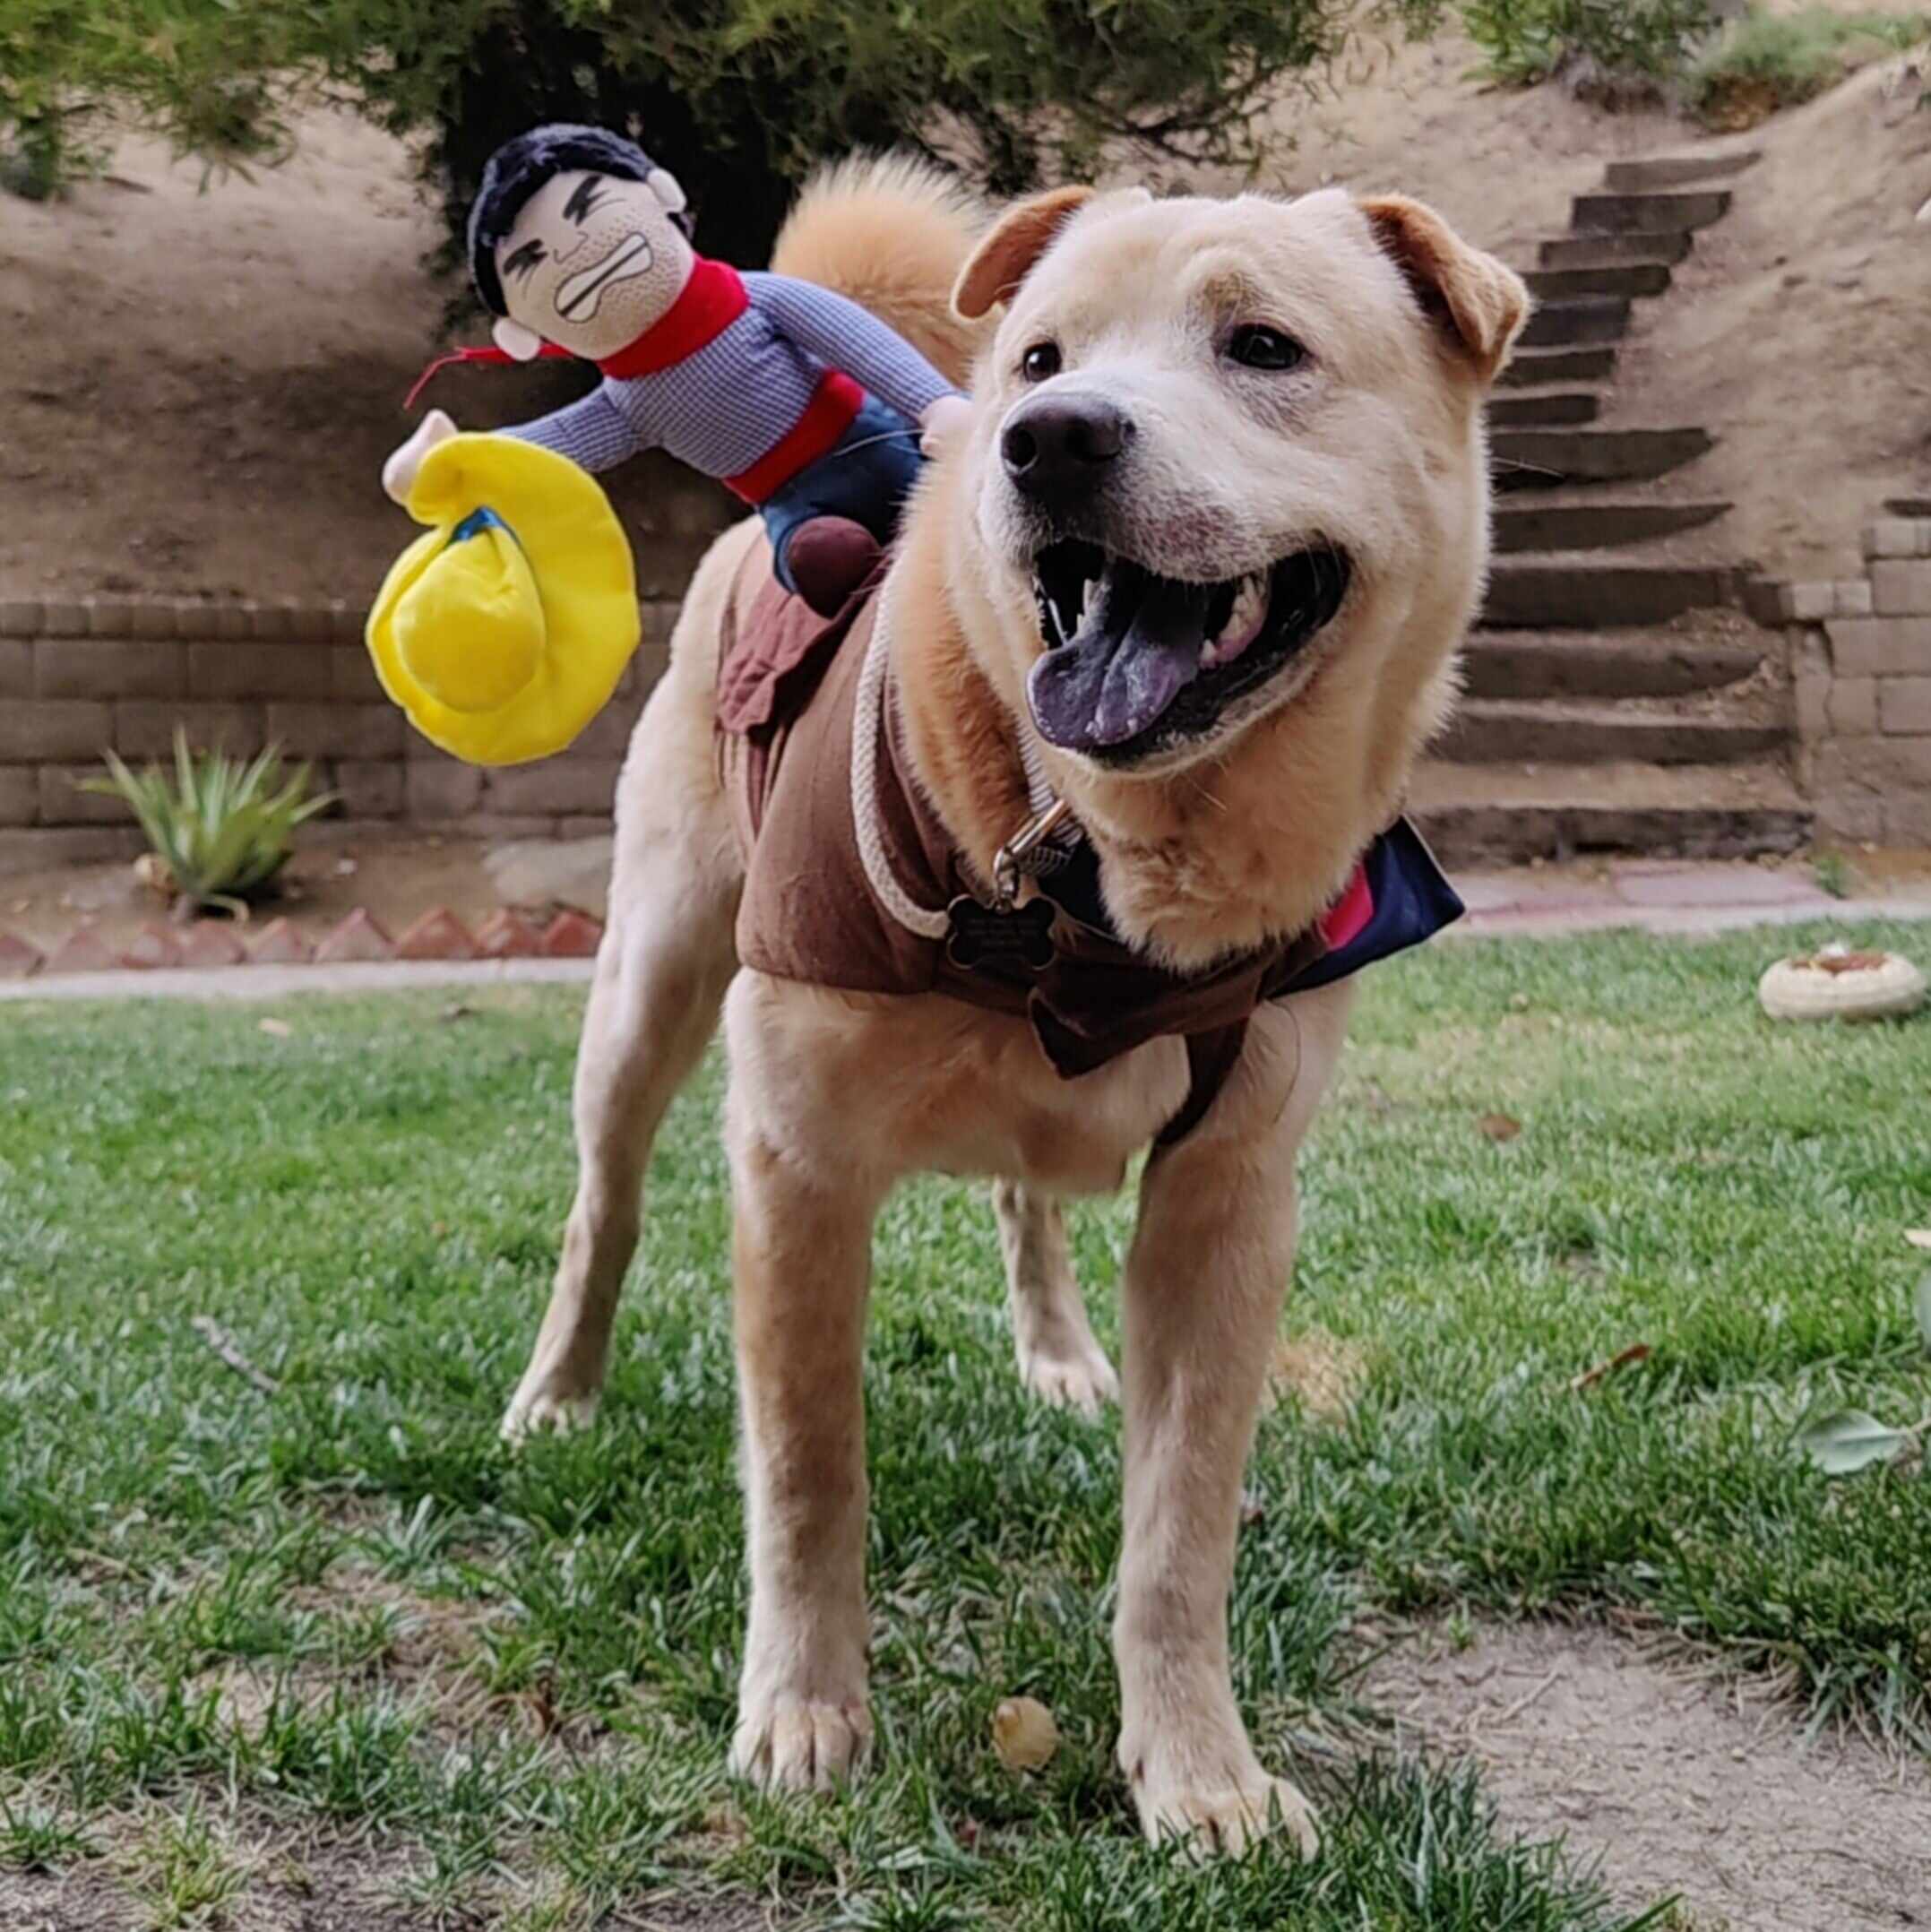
[383,125,966,615]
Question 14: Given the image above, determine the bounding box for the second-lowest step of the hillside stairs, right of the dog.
[1431,697,1790,765]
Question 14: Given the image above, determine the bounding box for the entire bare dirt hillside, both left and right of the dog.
[0,21,1931,597]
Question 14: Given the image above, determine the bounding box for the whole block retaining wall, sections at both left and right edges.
[11,503,1931,871]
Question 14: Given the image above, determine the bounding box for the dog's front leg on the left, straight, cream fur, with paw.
[730,1095,876,1791]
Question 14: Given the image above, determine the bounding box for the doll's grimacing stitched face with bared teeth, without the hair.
[496,170,695,361]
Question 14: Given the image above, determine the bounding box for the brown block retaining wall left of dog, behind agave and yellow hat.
[0,597,677,871]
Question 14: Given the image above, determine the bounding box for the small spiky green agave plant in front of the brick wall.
[82,730,336,919]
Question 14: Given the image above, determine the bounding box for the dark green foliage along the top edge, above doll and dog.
[0,0,1443,263]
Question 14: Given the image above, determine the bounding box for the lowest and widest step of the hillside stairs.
[1409,759,1811,867]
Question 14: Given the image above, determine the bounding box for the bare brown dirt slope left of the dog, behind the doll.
[0,112,719,597]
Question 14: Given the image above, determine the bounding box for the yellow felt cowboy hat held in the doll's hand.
[366,436,641,765]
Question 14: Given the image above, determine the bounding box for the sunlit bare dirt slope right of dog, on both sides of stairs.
[1220,14,1931,578]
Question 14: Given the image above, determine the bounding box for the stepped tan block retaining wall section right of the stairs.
[1761,505,1931,846]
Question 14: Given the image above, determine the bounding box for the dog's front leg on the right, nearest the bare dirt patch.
[1114,995,1346,1853]
